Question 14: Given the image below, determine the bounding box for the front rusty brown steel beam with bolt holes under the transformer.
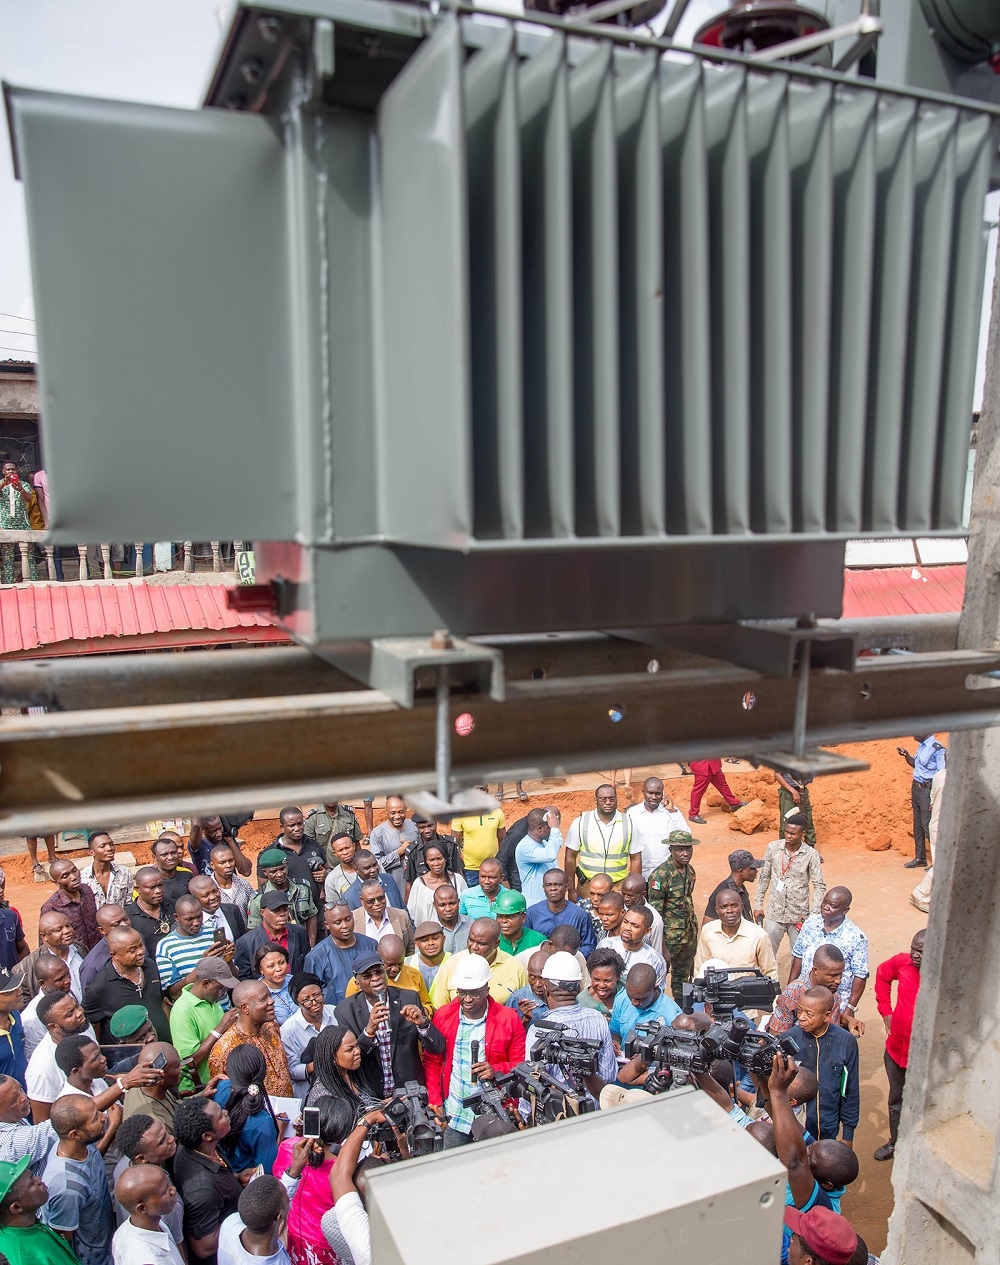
[0,651,1000,834]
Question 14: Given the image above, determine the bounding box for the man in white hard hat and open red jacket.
[422,953,528,1149]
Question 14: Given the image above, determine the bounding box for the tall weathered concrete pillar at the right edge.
[872,230,1000,1265]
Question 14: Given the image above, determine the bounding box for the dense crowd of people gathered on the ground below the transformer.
[0,753,923,1265]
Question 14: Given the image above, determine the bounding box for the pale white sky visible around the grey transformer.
[0,0,1000,409]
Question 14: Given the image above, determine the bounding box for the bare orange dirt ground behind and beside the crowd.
[3,735,941,1254]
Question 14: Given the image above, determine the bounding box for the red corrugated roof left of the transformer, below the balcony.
[0,581,290,657]
